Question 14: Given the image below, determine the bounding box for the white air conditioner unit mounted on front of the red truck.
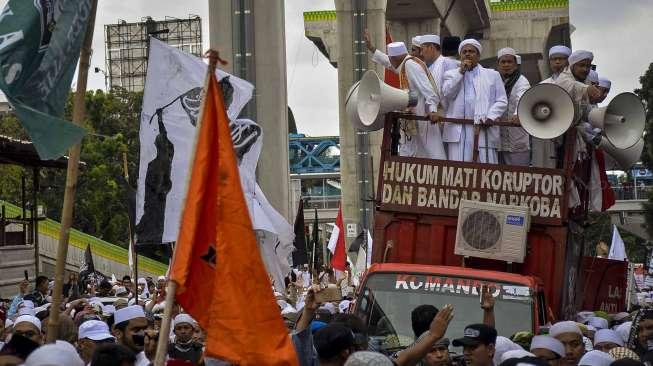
[454,200,531,263]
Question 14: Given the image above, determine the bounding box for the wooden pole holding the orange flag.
[154,50,225,366]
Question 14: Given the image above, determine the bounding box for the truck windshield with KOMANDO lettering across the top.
[357,273,534,354]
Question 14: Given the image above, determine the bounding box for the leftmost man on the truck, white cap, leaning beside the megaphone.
[388,42,446,159]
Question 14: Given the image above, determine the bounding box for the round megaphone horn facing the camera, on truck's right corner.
[517,84,576,139]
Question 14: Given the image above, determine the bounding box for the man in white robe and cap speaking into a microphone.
[442,39,508,164]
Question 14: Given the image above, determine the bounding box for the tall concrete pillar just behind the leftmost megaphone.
[335,0,386,244]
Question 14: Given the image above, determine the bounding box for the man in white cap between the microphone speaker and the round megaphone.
[497,47,531,166]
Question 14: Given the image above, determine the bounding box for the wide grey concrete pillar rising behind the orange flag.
[209,0,292,221]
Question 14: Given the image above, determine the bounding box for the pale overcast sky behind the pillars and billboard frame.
[0,0,653,136]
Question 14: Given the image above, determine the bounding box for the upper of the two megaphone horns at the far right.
[588,92,646,149]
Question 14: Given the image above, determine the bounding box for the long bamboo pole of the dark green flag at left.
[47,0,97,343]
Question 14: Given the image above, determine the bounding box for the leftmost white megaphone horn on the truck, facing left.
[345,70,417,131]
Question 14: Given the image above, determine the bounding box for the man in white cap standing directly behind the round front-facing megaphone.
[531,45,571,168]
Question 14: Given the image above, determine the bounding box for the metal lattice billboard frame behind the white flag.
[104,15,202,92]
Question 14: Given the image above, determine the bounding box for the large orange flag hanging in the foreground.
[170,75,298,365]
